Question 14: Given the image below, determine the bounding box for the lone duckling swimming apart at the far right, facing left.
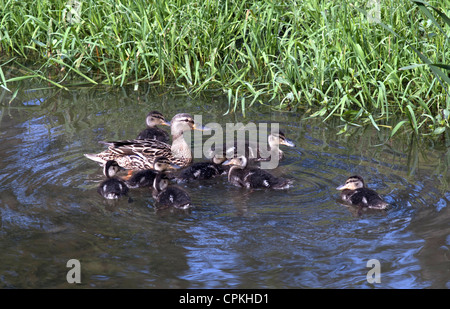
[336,175,389,209]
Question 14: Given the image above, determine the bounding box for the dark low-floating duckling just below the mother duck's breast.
[174,161,228,182]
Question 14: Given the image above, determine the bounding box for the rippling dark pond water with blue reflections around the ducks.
[0,86,450,289]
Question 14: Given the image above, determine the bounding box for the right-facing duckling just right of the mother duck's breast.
[211,131,295,163]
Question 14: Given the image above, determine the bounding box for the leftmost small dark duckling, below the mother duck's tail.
[97,160,129,199]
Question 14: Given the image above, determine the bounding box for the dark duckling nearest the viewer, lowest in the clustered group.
[152,173,191,209]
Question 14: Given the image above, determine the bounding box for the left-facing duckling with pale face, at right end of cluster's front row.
[223,156,292,189]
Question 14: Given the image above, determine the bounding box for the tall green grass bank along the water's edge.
[0,0,450,136]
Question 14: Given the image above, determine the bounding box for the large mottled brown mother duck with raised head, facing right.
[85,114,206,170]
